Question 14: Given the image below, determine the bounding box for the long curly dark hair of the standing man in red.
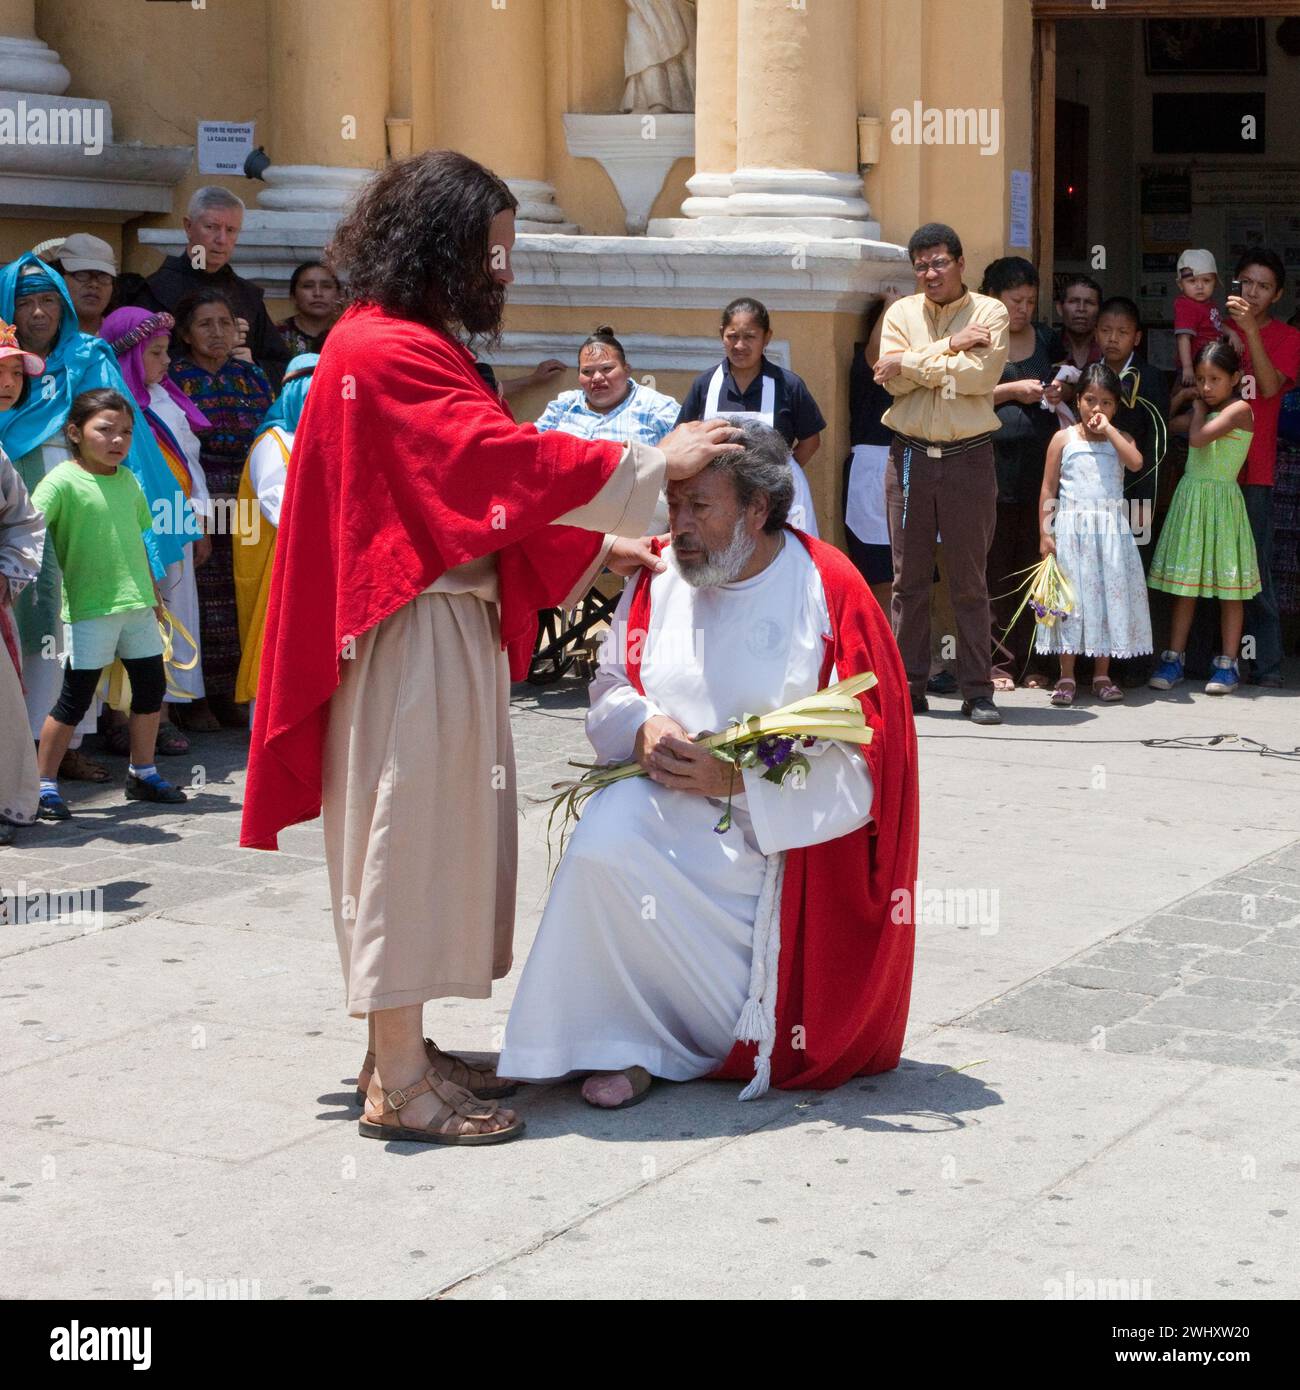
[327,150,519,338]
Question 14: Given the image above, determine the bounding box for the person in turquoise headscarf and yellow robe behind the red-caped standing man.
[234,352,320,719]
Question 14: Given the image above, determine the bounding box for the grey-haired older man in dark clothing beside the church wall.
[135,185,289,388]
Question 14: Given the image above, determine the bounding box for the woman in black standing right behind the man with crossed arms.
[980,256,1061,691]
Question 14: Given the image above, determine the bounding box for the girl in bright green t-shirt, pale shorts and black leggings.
[32,389,185,820]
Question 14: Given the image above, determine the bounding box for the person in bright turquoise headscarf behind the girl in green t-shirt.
[0,252,199,781]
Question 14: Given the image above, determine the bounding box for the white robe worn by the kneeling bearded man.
[498,534,872,1081]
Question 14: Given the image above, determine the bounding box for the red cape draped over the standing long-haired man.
[239,304,623,849]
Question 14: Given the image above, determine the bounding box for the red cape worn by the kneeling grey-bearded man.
[627,528,918,1090]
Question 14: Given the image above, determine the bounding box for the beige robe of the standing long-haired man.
[321,443,665,1017]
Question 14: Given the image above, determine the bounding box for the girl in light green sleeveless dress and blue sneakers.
[1147,339,1260,695]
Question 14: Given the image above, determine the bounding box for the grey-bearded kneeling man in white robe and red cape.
[498,420,916,1109]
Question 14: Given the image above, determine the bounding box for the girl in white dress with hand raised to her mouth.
[1036,361,1151,706]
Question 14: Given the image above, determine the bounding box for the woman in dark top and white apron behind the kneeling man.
[677,296,826,535]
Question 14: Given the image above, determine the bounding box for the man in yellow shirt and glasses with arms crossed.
[876,222,1008,724]
